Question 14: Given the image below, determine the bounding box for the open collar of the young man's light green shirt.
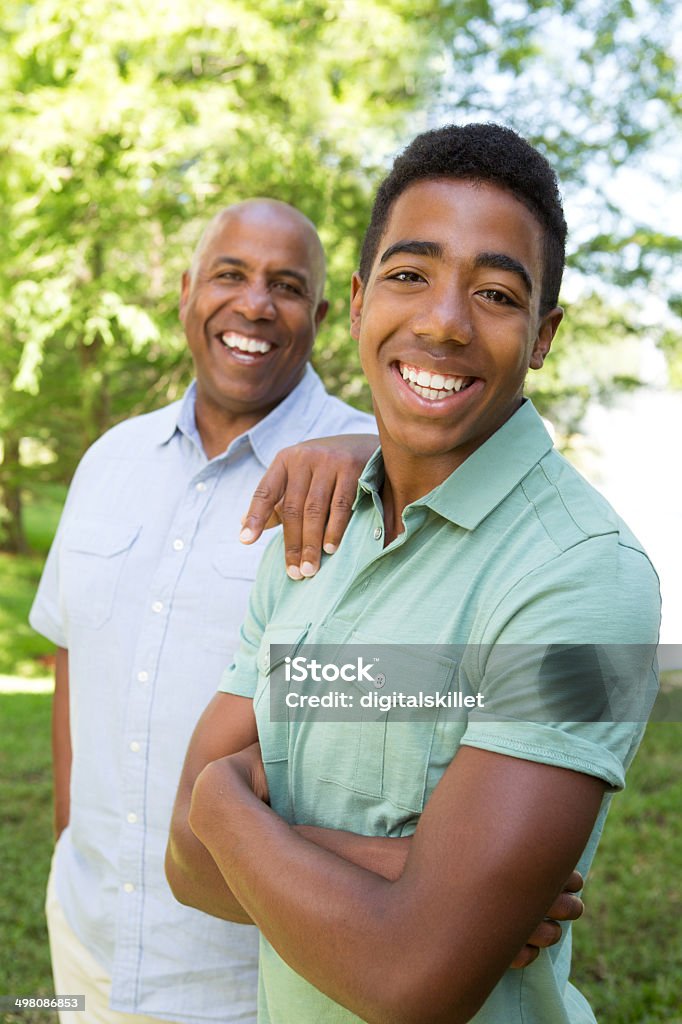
[353,398,553,529]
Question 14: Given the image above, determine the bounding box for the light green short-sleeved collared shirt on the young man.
[221,401,659,1024]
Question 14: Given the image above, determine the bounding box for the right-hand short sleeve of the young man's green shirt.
[462,535,660,788]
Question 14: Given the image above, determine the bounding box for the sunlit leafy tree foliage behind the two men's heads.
[0,0,680,548]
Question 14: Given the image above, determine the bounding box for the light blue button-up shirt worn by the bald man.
[31,367,375,1022]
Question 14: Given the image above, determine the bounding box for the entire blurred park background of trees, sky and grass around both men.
[0,0,682,1024]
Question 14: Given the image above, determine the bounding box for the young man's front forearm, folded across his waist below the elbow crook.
[189,765,417,1024]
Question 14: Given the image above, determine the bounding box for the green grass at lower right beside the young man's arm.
[573,722,682,1024]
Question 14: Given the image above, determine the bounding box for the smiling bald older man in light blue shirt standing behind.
[31,200,374,1024]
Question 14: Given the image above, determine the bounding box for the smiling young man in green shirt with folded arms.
[167,125,658,1024]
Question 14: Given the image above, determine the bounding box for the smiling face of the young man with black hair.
[351,179,561,479]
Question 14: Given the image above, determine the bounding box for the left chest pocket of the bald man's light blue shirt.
[59,519,140,629]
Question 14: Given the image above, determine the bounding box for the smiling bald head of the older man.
[180,201,327,416]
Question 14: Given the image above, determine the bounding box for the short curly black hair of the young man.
[359,124,566,313]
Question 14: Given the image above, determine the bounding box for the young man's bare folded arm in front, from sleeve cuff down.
[189,748,605,1024]
